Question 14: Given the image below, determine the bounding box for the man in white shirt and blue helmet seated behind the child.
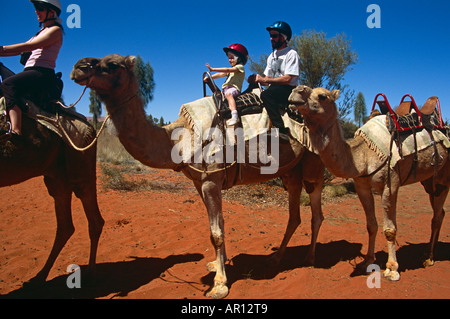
[254,21,299,141]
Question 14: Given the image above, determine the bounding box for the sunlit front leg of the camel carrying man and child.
[201,181,228,299]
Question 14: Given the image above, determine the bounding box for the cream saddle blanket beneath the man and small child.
[179,97,318,154]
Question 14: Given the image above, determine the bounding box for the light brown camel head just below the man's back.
[289,85,339,128]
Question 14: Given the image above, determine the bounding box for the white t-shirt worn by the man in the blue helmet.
[264,47,300,86]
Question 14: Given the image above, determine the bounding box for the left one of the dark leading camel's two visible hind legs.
[31,176,75,281]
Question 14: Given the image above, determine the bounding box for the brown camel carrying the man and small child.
[71,54,324,299]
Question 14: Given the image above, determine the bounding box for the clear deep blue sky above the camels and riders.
[0,0,450,122]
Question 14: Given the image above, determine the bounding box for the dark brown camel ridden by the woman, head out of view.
[0,105,104,283]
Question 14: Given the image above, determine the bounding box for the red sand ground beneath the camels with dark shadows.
[0,170,450,299]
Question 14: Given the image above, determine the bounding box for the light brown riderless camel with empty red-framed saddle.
[289,86,450,281]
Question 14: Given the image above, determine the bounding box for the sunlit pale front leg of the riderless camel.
[381,186,400,281]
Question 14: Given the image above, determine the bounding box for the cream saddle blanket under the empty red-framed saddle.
[355,115,450,167]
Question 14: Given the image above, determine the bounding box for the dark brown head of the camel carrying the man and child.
[70,54,138,99]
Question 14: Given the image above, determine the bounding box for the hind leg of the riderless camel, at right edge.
[422,178,449,267]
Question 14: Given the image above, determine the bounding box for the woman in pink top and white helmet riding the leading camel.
[0,0,63,135]
